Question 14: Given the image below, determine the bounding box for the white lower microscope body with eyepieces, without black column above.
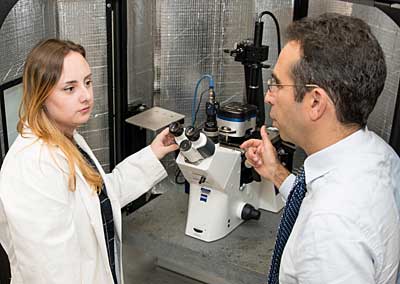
[169,122,284,242]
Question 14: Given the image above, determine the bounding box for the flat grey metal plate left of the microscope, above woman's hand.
[125,107,185,131]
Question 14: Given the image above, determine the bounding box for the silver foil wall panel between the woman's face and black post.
[57,0,110,171]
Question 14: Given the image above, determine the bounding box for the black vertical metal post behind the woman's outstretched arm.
[106,0,157,215]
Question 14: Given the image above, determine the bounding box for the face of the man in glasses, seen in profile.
[264,41,304,144]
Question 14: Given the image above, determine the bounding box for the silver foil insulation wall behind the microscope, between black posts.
[133,0,293,124]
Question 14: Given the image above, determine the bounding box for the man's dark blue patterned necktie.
[268,168,307,284]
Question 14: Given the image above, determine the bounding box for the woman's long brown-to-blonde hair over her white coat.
[17,39,103,192]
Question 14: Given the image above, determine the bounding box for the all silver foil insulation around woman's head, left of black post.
[0,0,109,170]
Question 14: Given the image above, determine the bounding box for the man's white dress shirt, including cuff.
[279,129,400,284]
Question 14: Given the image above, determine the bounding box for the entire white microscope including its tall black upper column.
[169,12,292,242]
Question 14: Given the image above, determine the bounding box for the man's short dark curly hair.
[287,13,386,127]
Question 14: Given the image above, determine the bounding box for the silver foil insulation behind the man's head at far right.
[308,0,400,141]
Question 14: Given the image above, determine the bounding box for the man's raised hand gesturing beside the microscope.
[240,126,290,188]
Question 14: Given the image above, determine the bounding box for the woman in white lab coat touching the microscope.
[0,39,177,284]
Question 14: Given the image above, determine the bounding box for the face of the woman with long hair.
[44,51,93,136]
